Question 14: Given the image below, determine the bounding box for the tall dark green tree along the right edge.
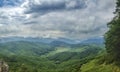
[105,0,120,61]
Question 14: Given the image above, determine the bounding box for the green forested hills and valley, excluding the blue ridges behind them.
[0,42,103,72]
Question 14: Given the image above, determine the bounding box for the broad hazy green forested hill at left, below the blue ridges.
[0,41,54,56]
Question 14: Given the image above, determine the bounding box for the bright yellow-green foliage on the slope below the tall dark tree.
[81,57,120,72]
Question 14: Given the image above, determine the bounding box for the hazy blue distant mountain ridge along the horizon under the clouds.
[0,37,104,44]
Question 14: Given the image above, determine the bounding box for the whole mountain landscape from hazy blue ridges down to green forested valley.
[0,37,104,72]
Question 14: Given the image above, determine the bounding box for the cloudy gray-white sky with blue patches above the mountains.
[0,0,115,39]
